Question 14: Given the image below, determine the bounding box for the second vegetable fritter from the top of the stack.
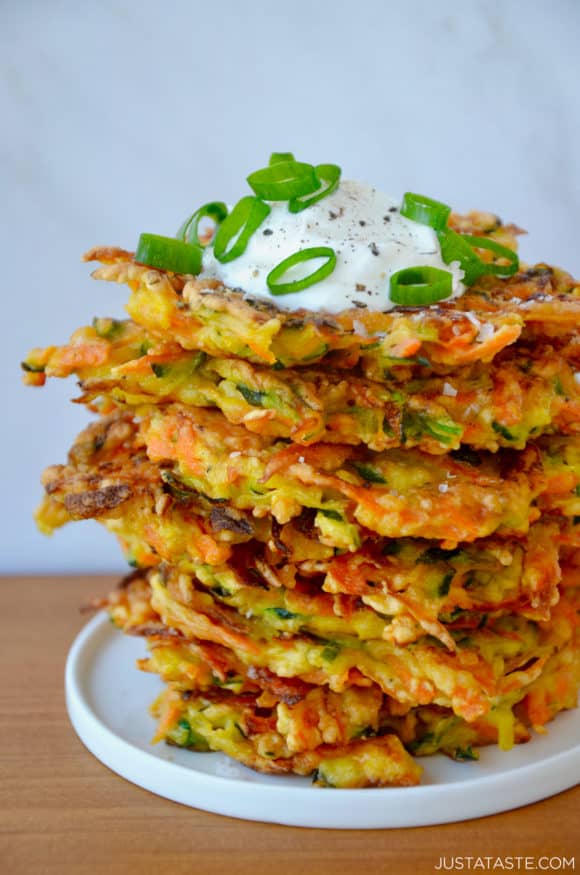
[23,319,580,454]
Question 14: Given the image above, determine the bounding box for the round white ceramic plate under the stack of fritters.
[66,613,580,829]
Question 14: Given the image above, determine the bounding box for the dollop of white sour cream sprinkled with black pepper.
[199,180,465,313]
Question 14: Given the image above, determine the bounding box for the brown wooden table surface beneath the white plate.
[0,576,580,875]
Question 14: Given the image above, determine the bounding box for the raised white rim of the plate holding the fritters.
[65,611,580,829]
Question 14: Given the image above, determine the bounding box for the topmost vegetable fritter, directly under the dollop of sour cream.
[85,247,580,367]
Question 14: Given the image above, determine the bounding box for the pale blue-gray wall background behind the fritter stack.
[0,0,580,572]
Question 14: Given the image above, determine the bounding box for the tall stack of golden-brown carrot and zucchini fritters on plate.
[24,192,580,787]
